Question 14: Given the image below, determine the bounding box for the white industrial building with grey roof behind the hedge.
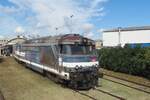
[103,26,150,47]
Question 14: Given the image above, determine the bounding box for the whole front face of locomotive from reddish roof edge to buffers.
[59,36,99,89]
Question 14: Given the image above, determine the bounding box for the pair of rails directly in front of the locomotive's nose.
[74,88,126,100]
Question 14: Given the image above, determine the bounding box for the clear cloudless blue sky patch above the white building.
[99,0,150,28]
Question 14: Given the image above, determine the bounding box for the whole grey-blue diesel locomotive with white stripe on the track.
[14,34,99,89]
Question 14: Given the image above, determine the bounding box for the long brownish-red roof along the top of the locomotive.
[25,34,94,44]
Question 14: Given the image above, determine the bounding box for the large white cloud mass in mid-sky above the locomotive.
[0,0,107,38]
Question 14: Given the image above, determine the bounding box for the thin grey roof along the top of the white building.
[103,26,150,32]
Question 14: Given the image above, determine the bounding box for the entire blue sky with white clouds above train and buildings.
[0,0,150,39]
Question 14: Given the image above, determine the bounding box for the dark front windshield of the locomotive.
[61,44,92,55]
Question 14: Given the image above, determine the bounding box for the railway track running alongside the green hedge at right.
[103,74,150,94]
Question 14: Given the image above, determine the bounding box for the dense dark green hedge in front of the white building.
[98,46,150,79]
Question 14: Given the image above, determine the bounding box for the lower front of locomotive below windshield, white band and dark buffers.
[63,55,99,89]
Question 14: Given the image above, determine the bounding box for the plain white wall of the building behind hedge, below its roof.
[103,30,150,46]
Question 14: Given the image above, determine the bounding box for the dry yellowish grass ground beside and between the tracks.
[0,57,150,100]
